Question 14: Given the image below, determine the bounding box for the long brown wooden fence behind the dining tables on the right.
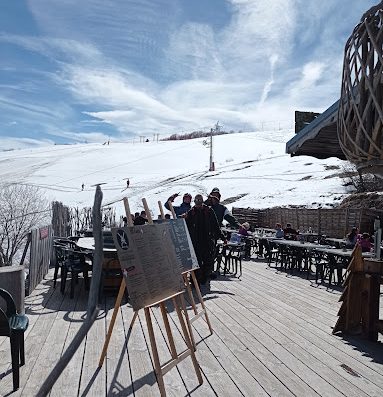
[232,207,383,238]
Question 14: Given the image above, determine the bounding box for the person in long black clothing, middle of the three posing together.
[185,194,221,284]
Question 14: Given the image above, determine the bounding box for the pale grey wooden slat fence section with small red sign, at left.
[26,225,53,295]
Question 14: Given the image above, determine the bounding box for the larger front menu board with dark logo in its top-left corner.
[112,222,184,311]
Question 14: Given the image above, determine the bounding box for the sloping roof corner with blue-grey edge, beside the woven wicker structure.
[286,100,346,160]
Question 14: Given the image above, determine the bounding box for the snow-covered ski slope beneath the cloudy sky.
[0,130,347,216]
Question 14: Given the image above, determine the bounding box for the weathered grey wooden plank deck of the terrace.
[0,261,383,397]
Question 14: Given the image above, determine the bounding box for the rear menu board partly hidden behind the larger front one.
[167,218,199,272]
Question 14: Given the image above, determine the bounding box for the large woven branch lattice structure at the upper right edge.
[337,1,383,176]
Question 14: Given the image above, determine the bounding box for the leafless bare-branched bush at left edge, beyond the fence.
[0,184,49,266]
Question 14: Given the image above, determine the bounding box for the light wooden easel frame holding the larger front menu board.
[98,197,203,396]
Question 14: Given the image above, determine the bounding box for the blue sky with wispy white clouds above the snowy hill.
[0,0,377,149]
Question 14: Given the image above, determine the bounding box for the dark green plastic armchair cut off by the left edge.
[0,288,29,390]
